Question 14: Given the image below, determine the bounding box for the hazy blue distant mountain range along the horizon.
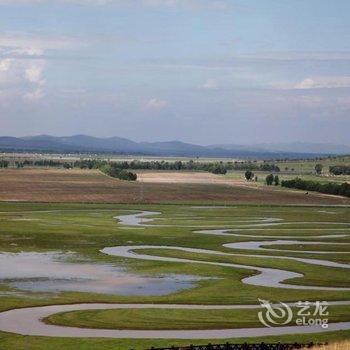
[0,135,350,158]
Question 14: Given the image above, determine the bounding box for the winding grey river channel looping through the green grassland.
[0,211,350,339]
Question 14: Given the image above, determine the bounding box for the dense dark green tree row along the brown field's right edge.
[281,178,350,197]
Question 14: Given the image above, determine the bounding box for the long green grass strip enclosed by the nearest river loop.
[45,306,350,330]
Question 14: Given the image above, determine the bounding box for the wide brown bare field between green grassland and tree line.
[0,169,350,204]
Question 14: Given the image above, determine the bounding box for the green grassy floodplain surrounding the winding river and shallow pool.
[0,201,350,350]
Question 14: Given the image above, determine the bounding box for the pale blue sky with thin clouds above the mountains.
[0,0,350,145]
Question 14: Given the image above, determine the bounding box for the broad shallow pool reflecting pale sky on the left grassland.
[0,252,199,295]
